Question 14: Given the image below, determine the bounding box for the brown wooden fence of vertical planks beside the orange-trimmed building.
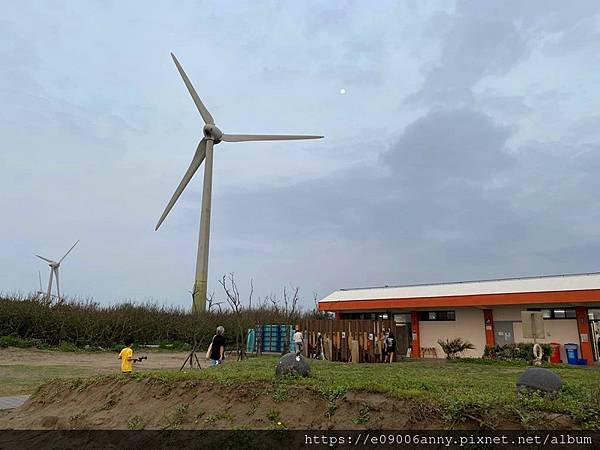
[299,320,410,362]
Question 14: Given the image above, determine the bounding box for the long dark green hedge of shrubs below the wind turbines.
[0,296,326,350]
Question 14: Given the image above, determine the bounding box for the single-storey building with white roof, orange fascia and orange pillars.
[319,273,600,364]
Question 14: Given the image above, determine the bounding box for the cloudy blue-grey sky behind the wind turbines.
[0,0,600,308]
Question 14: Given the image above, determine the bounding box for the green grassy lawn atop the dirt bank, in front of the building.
[47,357,600,430]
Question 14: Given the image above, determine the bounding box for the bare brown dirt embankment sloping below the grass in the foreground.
[0,379,573,430]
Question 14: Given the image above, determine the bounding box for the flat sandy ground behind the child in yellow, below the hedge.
[0,348,206,396]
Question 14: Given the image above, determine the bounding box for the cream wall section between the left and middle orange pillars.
[419,308,485,358]
